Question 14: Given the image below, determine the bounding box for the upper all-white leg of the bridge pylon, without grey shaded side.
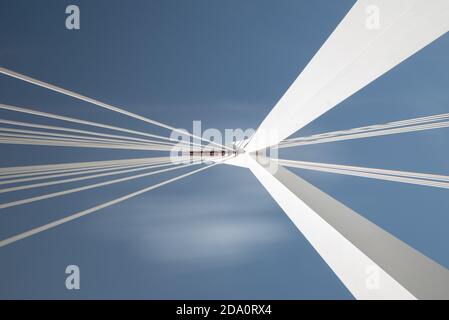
[245,0,449,151]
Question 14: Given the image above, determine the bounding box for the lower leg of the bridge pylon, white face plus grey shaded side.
[245,156,449,299]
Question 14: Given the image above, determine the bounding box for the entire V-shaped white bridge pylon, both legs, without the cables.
[225,0,449,299]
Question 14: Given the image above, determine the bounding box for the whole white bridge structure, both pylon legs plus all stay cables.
[0,0,449,299]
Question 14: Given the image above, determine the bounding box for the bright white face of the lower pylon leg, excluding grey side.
[242,156,416,299]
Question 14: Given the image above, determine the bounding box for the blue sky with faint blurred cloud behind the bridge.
[0,0,449,299]
